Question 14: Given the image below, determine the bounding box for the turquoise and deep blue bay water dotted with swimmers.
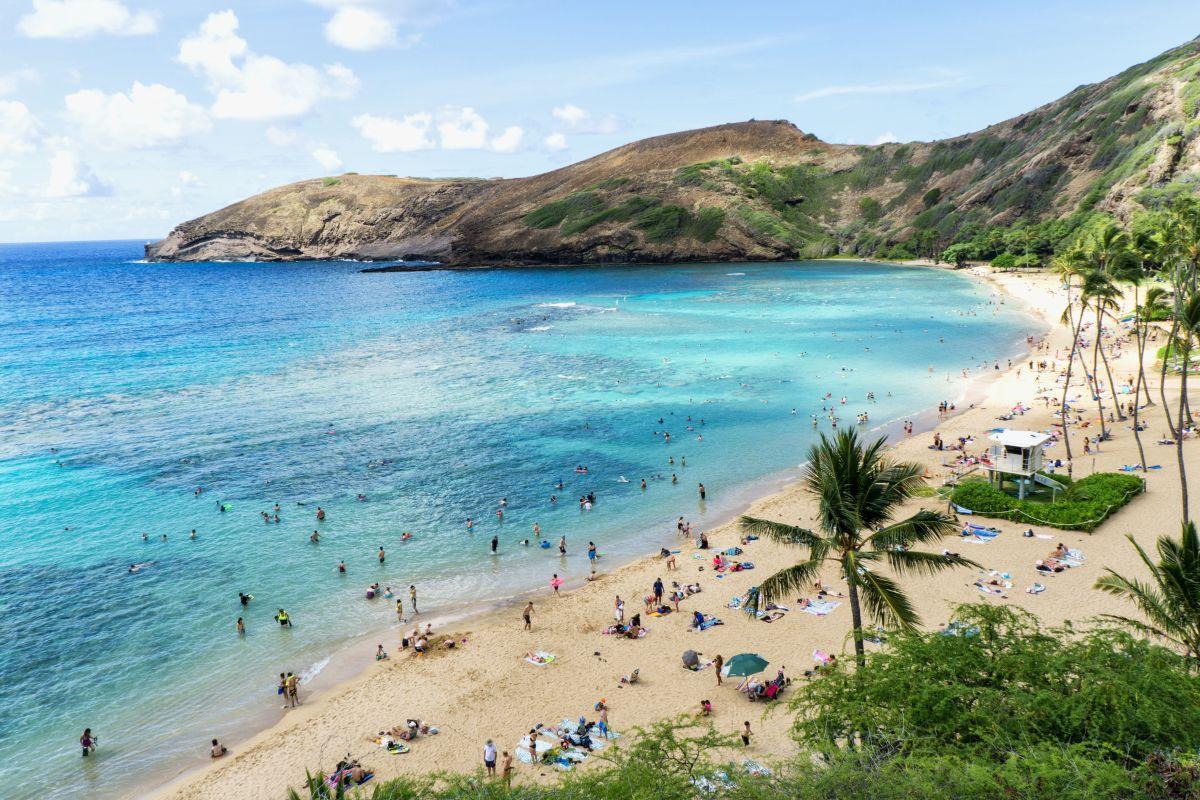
[0,242,1034,798]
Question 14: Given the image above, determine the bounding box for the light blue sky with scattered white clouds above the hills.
[0,0,1200,242]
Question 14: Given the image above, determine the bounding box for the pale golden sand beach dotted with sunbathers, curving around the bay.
[150,270,1180,800]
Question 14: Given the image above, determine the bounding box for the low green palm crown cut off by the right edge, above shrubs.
[1096,522,1200,666]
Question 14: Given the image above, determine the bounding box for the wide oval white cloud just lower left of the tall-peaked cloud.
[65,82,212,149]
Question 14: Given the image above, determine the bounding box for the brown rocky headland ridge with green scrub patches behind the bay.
[146,38,1200,266]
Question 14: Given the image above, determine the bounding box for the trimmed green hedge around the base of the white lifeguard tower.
[950,473,1142,531]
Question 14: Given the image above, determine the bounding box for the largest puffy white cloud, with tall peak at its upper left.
[179,11,359,120]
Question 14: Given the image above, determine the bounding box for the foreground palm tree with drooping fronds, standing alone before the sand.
[742,429,979,664]
